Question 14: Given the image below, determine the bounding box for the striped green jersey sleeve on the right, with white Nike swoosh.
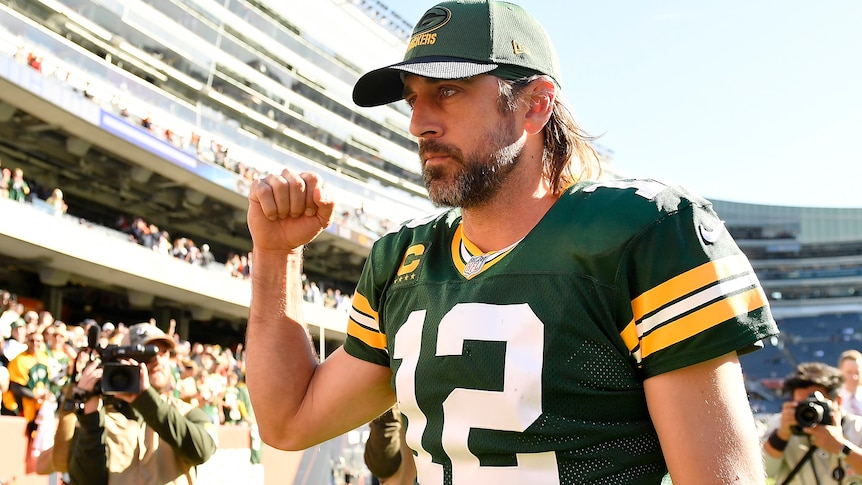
[620,195,778,378]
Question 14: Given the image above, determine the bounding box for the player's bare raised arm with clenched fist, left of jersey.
[246,170,395,450]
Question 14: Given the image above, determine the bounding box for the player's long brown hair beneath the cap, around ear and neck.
[499,75,602,195]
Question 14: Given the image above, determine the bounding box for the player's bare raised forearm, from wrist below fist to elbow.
[246,248,317,447]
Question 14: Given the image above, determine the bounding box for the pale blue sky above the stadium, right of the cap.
[383,0,862,208]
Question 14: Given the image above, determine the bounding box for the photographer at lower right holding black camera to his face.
[763,362,862,485]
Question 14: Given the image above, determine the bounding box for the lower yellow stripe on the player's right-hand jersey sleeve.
[640,287,766,358]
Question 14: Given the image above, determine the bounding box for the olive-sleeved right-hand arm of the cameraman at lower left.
[132,387,216,465]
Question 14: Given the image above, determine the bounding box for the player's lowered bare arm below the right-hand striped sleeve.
[644,353,765,485]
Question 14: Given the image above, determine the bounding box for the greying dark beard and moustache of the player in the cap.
[419,116,524,209]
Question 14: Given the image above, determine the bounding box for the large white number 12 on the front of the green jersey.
[393,303,560,485]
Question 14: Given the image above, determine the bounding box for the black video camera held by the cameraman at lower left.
[93,345,159,394]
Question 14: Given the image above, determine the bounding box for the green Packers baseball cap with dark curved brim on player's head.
[353,0,561,107]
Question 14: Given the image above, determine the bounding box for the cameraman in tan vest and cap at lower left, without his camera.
[69,323,216,485]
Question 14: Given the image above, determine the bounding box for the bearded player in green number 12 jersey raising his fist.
[246,0,777,485]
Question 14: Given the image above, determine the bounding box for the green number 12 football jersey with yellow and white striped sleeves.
[344,180,778,485]
